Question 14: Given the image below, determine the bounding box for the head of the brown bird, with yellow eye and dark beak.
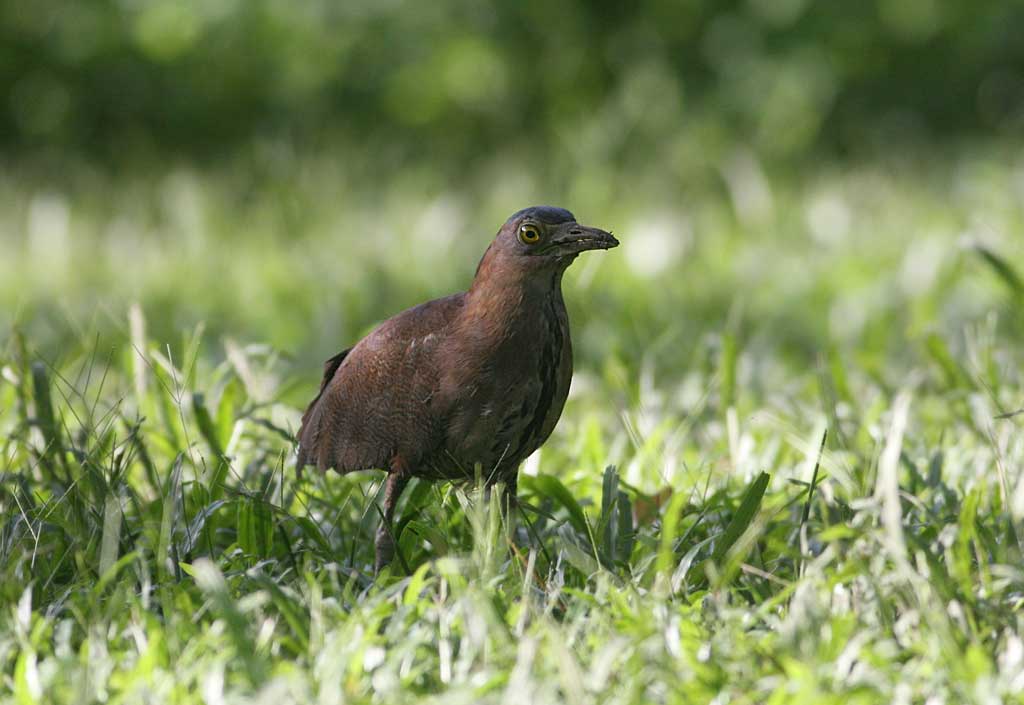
[485,206,618,269]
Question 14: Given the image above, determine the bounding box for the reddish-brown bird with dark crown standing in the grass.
[296,206,618,573]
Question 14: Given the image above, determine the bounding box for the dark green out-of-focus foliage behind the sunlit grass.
[6,0,1024,177]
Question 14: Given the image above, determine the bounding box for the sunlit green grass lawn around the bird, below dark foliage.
[0,143,1024,705]
